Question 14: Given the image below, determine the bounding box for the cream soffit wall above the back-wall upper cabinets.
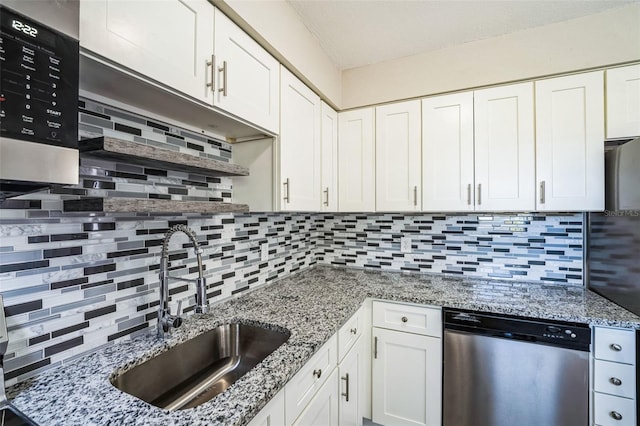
[341,3,640,109]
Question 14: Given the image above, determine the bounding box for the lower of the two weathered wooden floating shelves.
[64,198,249,214]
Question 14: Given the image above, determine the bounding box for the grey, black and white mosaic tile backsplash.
[0,99,583,385]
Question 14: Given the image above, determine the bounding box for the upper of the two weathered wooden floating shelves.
[78,137,249,176]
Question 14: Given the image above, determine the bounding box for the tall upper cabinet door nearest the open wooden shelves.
[280,68,322,211]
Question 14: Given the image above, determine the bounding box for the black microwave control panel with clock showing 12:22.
[0,7,79,148]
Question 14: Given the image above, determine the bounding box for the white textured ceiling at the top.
[287,0,640,69]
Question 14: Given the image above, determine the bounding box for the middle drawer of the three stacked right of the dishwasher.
[593,359,636,399]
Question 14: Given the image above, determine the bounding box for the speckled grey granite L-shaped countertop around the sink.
[9,266,640,426]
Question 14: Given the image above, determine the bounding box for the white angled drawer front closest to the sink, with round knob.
[285,334,338,425]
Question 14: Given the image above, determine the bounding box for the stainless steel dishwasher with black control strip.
[443,309,591,426]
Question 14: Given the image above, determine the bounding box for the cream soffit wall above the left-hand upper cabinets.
[215,0,342,108]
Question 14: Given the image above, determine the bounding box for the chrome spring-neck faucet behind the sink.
[158,225,209,337]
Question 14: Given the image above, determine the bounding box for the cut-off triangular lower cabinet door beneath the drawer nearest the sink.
[293,368,339,426]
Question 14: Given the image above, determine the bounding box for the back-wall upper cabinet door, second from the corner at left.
[376,100,422,211]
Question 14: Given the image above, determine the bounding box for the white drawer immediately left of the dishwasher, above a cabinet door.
[373,301,442,337]
